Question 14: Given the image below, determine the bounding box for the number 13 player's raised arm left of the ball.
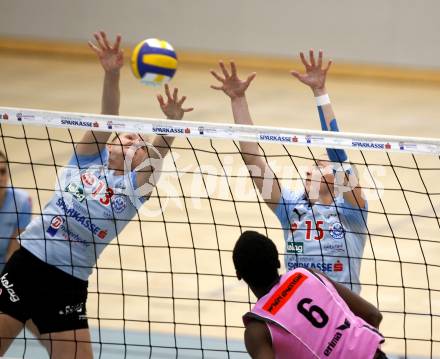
[76,31,124,156]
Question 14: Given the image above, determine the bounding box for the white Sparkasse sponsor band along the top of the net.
[0,107,440,155]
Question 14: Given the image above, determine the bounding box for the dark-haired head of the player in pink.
[232,231,281,291]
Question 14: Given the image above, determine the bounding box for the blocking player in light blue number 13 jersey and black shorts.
[0,32,191,359]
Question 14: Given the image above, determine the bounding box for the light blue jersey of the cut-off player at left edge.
[0,187,32,272]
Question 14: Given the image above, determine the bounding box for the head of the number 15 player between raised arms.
[305,160,335,203]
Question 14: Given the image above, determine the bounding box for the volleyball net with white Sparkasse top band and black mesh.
[0,108,440,358]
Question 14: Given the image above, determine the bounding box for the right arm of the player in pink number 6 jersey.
[311,270,382,328]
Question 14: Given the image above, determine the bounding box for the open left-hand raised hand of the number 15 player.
[210,61,257,100]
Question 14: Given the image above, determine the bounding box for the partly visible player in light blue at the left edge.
[0,151,32,272]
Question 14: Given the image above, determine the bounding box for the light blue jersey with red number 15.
[275,189,368,293]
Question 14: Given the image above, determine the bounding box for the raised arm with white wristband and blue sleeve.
[291,50,366,208]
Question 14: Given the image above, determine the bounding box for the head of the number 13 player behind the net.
[108,132,148,171]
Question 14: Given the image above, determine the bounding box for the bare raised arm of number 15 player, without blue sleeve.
[211,62,281,211]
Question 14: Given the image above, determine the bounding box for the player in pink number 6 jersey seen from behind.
[233,231,386,359]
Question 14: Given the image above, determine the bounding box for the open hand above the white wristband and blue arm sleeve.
[290,50,332,90]
